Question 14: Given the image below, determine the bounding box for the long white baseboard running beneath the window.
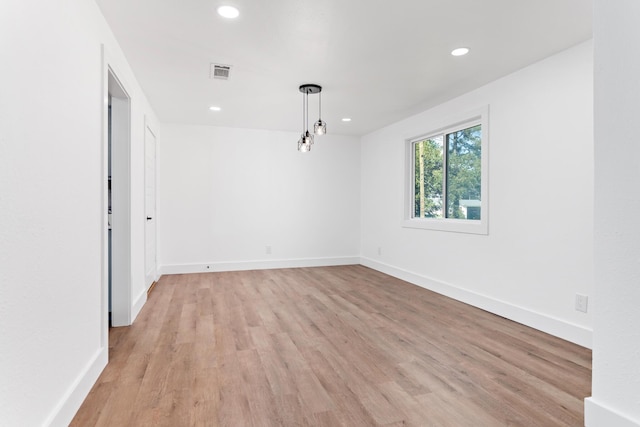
[360,257,593,348]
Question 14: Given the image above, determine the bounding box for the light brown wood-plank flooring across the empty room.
[71,266,591,427]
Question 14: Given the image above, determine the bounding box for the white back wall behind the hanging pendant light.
[158,125,360,274]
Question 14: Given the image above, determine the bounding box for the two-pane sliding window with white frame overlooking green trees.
[404,108,488,234]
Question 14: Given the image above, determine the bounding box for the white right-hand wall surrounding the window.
[361,42,593,346]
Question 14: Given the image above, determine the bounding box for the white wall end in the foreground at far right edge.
[585,0,640,427]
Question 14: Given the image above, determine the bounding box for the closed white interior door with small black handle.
[144,126,157,289]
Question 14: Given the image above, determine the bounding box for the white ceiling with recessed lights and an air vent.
[96,0,592,135]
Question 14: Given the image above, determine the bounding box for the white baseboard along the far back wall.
[160,257,360,275]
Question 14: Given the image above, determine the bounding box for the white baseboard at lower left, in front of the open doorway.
[43,347,109,427]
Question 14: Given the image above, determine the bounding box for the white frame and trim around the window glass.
[402,105,489,235]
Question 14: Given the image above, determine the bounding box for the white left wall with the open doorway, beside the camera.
[0,0,155,426]
